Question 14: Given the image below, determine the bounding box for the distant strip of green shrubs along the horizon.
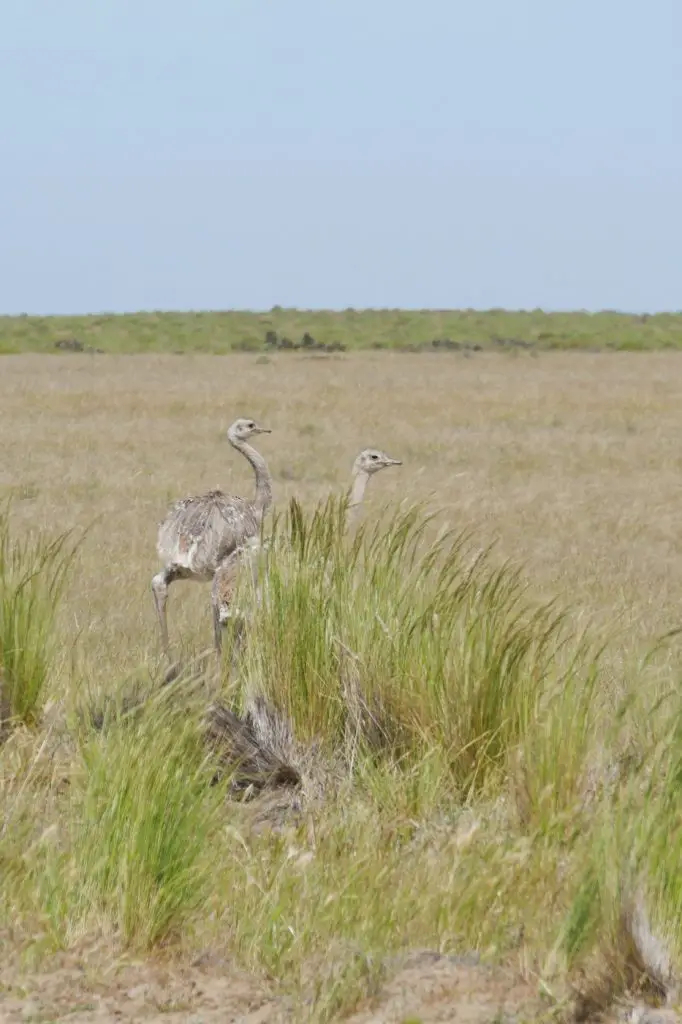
[0,306,682,354]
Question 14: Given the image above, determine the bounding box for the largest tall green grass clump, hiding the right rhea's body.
[232,499,595,809]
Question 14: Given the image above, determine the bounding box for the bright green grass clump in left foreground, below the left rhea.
[34,692,224,949]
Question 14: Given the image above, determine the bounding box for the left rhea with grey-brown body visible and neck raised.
[152,419,272,660]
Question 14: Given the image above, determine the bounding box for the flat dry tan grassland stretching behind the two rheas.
[5,353,682,667]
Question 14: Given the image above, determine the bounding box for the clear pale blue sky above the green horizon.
[0,0,682,313]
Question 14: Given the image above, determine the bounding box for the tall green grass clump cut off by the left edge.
[0,502,73,730]
